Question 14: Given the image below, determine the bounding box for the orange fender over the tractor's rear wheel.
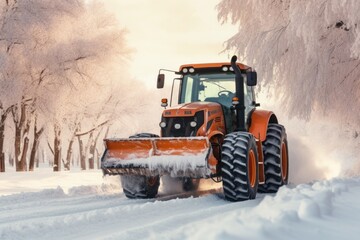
[249,109,278,142]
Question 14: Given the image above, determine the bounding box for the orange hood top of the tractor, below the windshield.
[163,102,222,117]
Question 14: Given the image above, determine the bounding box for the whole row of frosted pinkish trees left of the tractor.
[0,0,138,171]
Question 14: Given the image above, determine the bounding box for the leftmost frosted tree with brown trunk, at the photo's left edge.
[0,0,85,171]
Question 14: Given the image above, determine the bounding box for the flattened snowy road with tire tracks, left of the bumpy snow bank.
[0,185,264,239]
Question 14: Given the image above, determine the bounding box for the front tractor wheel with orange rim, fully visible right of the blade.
[221,132,259,201]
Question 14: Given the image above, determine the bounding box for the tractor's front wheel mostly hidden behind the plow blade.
[121,175,160,199]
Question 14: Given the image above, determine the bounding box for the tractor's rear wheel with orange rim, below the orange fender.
[259,123,289,193]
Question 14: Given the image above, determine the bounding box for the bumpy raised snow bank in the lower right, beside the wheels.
[162,179,360,239]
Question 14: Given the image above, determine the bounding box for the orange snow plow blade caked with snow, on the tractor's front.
[101,137,217,178]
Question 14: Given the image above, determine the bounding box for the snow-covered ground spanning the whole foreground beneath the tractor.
[0,169,360,239]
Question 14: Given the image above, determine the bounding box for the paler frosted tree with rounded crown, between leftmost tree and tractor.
[37,0,129,172]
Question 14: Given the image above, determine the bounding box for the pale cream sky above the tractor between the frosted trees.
[104,0,237,88]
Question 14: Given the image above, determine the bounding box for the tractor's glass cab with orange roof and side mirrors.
[158,63,256,133]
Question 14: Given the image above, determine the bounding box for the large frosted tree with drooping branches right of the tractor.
[217,0,360,129]
